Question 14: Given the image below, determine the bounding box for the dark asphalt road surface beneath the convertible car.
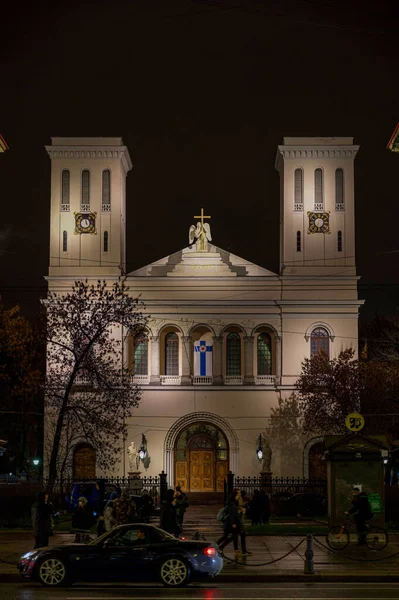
[0,582,399,600]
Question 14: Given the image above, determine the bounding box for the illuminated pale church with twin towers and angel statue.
[47,137,362,492]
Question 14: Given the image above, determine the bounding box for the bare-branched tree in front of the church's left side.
[44,280,146,490]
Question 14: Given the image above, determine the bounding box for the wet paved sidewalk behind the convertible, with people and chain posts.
[0,532,399,583]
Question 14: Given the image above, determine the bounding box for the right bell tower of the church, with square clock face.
[275,137,359,277]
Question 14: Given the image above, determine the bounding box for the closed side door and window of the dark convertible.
[102,525,153,581]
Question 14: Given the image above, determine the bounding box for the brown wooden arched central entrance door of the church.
[174,423,229,492]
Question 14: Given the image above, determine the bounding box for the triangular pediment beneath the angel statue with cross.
[128,244,278,278]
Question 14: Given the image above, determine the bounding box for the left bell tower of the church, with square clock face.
[46,137,132,279]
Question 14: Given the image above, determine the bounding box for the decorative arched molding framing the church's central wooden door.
[163,412,239,487]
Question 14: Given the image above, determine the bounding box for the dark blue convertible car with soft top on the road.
[19,523,223,587]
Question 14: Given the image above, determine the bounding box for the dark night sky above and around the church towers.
[0,0,399,324]
